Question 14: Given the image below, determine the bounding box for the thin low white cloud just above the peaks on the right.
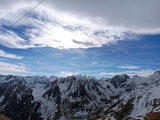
[100,69,155,77]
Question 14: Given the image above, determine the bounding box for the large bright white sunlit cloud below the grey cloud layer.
[0,0,133,49]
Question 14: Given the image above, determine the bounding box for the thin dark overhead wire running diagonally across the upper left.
[0,0,45,35]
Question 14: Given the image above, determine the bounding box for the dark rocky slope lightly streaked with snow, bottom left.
[0,79,41,120]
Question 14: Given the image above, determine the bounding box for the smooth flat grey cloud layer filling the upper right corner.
[46,0,160,34]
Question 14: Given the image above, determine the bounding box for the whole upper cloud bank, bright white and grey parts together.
[0,0,160,49]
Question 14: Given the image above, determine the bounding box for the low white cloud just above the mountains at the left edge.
[0,61,28,75]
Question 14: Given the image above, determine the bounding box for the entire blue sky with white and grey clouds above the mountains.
[0,0,160,78]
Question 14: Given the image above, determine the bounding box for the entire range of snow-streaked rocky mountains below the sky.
[0,71,160,120]
